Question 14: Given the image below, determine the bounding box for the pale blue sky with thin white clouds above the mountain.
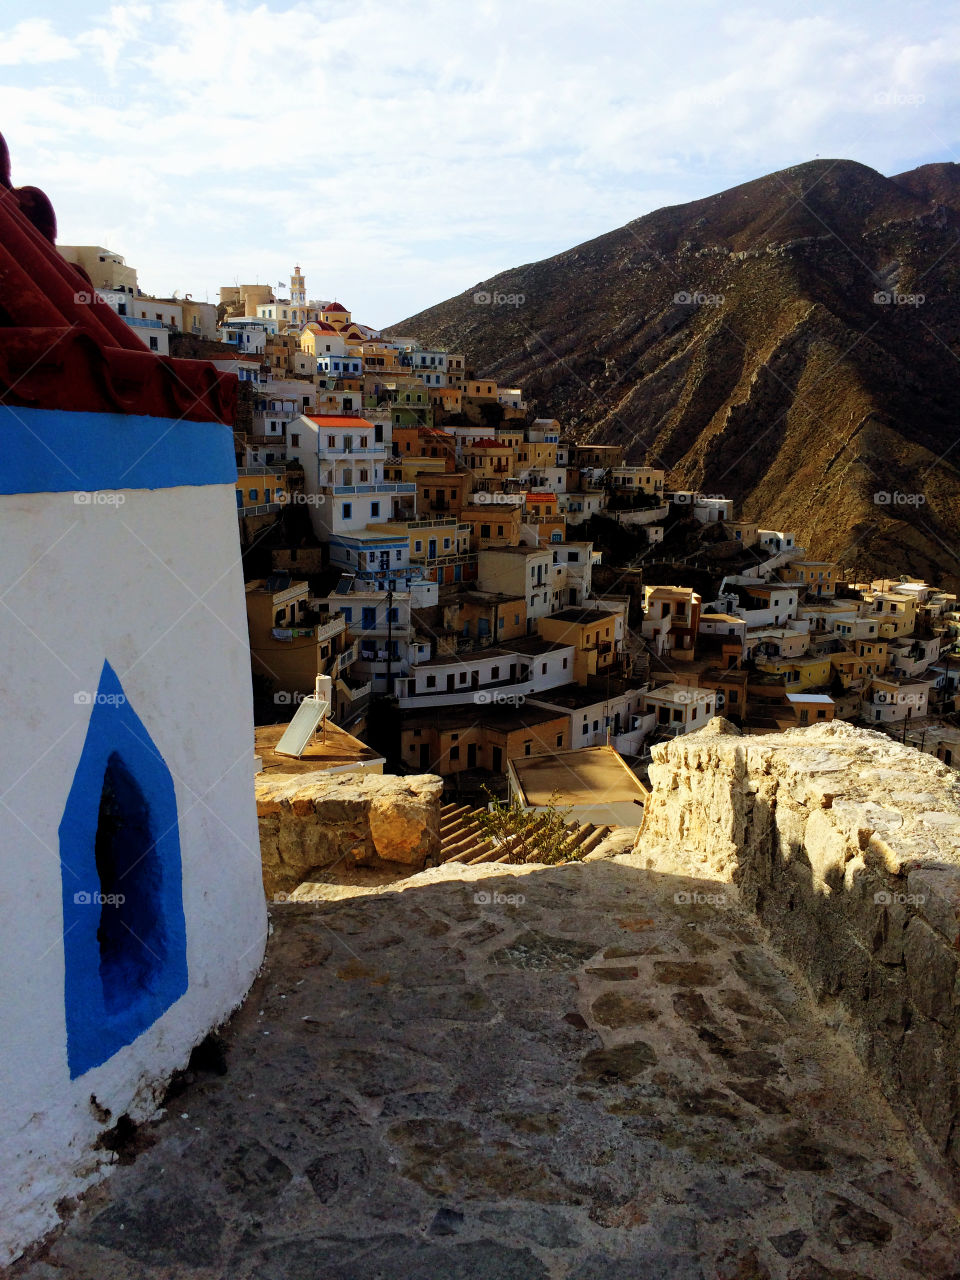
[0,0,960,328]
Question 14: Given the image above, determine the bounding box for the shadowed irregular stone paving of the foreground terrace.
[12,856,960,1280]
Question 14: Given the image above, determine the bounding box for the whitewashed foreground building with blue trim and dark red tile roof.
[0,175,266,1266]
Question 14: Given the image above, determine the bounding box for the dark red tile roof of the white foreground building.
[0,136,237,424]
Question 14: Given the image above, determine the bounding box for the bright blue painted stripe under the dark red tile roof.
[0,404,237,494]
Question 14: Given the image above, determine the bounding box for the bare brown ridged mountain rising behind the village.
[393,160,960,585]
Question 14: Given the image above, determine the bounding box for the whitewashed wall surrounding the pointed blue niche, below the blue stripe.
[0,481,265,1262]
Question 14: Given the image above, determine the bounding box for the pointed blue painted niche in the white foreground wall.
[60,662,188,1079]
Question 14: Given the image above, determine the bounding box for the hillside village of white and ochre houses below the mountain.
[67,247,960,794]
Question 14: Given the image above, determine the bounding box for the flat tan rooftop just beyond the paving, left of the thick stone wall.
[511,746,648,803]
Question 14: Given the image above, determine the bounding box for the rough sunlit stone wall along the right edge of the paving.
[637,721,960,1165]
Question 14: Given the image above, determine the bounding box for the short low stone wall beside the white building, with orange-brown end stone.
[256,771,443,897]
